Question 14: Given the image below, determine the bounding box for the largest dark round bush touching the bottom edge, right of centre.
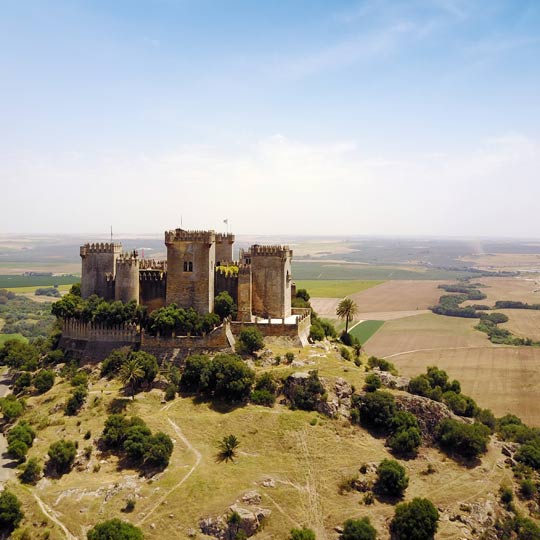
[390,498,439,540]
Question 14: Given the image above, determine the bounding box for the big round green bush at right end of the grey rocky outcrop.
[437,419,490,459]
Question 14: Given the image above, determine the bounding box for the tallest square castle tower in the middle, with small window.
[165,229,216,314]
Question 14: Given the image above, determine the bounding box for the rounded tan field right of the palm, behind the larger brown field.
[366,313,491,356]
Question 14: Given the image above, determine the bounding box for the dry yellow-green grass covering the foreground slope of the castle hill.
[7,347,511,540]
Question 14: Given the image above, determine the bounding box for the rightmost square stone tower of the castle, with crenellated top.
[247,245,292,319]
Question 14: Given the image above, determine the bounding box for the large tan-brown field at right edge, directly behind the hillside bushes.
[388,346,540,426]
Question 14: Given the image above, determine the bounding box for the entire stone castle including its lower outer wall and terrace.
[60,229,311,362]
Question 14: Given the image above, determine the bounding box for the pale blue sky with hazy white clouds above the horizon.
[0,0,540,238]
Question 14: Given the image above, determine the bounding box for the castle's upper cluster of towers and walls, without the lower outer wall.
[80,229,295,322]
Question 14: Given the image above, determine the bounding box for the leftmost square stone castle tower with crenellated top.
[80,242,122,300]
